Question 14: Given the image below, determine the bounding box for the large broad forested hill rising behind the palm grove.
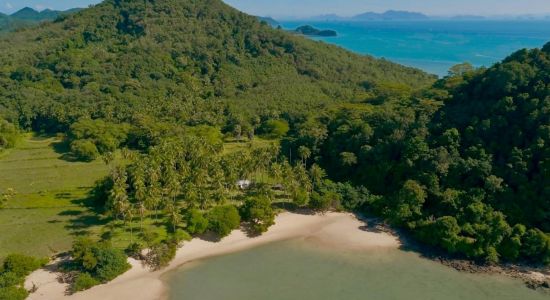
[0,0,434,131]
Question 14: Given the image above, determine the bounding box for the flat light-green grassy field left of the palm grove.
[0,136,108,257]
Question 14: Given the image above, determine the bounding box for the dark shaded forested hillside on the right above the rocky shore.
[283,46,550,263]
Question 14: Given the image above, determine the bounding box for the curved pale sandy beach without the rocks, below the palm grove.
[25,213,399,300]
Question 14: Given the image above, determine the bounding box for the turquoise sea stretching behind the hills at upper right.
[281,20,550,75]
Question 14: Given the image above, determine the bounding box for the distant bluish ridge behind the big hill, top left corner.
[0,7,81,33]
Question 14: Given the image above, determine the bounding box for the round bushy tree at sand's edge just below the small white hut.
[241,196,275,233]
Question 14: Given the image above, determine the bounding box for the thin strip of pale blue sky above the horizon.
[0,0,550,17]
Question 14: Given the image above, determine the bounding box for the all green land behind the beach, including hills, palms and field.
[0,0,550,293]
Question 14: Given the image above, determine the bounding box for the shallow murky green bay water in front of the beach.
[167,240,550,300]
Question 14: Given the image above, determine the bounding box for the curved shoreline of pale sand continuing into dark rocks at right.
[25,212,550,300]
